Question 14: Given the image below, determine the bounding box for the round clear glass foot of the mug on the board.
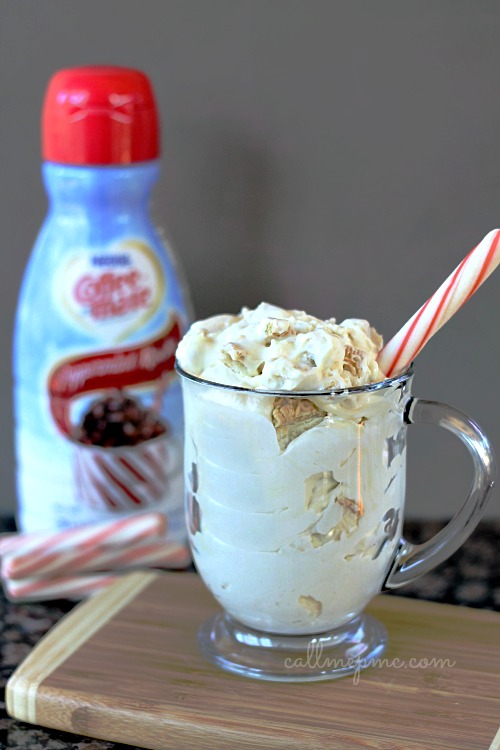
[198,612,387,682]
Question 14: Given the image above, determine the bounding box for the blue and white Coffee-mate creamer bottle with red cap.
[14,66,189,541]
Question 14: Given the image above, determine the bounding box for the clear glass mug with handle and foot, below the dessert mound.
[177,365,495,681]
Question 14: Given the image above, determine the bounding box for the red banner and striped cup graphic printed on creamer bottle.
[49,322,181,513]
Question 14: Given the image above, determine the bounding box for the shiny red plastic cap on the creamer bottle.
[42,65,160,164]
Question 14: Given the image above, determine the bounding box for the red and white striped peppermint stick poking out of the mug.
[378,229,500,378]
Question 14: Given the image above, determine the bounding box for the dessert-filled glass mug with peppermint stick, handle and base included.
[176,230,500,681]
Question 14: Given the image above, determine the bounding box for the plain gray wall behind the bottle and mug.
[0,0,500,518]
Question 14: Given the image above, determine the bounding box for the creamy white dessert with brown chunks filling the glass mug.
[177,303,410,635]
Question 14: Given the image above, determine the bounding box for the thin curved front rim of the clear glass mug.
[175,359,414,398]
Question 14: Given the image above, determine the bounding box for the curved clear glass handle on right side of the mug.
[382,398,496,590]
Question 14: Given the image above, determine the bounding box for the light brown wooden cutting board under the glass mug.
[7,572,500,750]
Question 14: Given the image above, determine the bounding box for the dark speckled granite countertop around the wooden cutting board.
[0,520,500,750]
